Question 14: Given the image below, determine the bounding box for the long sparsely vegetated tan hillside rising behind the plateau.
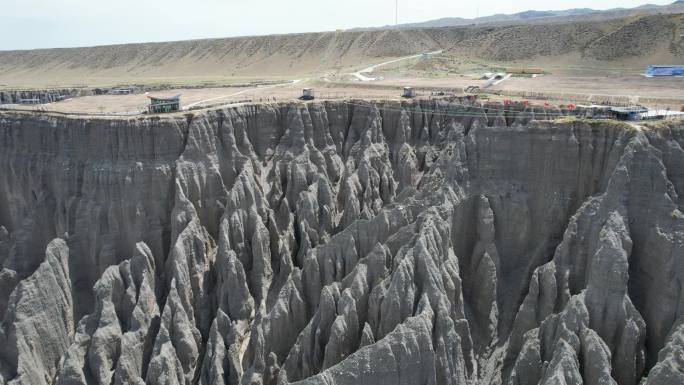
[0,14,684,87]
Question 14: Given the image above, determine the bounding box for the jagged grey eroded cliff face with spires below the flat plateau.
[0,101,684,385]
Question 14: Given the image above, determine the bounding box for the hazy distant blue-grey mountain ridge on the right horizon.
[358,0,684,30]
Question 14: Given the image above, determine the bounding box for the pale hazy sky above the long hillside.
[0,0,674,50]
